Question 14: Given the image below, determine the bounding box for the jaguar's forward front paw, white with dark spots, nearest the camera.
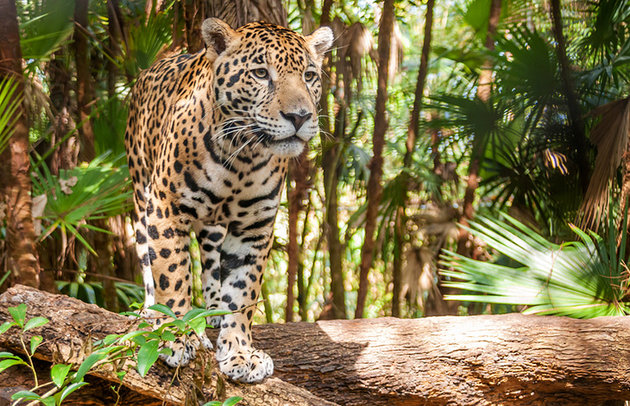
[217,340,273,383]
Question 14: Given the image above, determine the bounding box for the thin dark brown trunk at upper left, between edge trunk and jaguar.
[73,0,95,161]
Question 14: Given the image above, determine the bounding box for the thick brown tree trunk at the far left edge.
[0,0,40,287]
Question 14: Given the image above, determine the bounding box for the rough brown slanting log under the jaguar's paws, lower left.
[0,285,335,406]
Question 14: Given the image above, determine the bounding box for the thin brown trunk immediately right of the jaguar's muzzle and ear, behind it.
[319,0,346,319]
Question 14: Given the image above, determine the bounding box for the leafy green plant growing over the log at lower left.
[0,303,232,406]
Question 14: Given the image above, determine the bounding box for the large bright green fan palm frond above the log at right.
[441,215,630,318]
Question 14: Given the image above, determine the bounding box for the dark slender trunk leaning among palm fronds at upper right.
[550,0,591,194]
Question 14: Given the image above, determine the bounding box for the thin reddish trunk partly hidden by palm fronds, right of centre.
[457,0,501,256]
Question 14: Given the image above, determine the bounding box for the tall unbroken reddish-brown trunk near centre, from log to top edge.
[354,0,398,318]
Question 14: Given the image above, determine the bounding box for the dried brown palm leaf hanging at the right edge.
[579,98,630,229]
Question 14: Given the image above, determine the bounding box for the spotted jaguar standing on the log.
[125,18,333,383]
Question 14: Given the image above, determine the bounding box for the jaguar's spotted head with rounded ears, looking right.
[202,18,333,157]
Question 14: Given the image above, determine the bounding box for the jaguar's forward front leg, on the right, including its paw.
[217,227,273,383]
